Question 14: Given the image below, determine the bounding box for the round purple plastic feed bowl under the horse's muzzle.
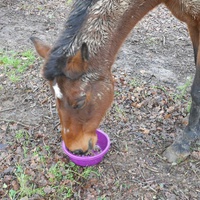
[62,129,110,167]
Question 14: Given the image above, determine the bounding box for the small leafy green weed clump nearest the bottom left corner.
[9,164,45,199]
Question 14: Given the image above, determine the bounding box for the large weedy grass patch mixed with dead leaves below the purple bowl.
[8,129,100,200]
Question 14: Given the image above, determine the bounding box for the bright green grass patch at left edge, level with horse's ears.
[0,50,35,83]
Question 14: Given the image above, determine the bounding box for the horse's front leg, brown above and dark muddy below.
[163,26,200,163]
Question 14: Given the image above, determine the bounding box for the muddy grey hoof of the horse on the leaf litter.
[163,142,190,163]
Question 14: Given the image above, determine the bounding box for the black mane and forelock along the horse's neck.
[44,0,98,80]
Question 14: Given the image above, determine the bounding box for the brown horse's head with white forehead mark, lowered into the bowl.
[31,37,114,153]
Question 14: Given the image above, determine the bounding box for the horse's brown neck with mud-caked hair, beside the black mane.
[86,0,164,68]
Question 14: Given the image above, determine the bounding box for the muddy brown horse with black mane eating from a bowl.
[31,0,200,162]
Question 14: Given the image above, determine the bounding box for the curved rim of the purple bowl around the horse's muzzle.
[62,129,110,161]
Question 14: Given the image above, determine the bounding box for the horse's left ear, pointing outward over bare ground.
[30,37,51,58]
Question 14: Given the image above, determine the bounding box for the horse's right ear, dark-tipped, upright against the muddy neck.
[64,43,89,79]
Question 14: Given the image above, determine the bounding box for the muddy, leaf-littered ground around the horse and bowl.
[0,0,200,200]
